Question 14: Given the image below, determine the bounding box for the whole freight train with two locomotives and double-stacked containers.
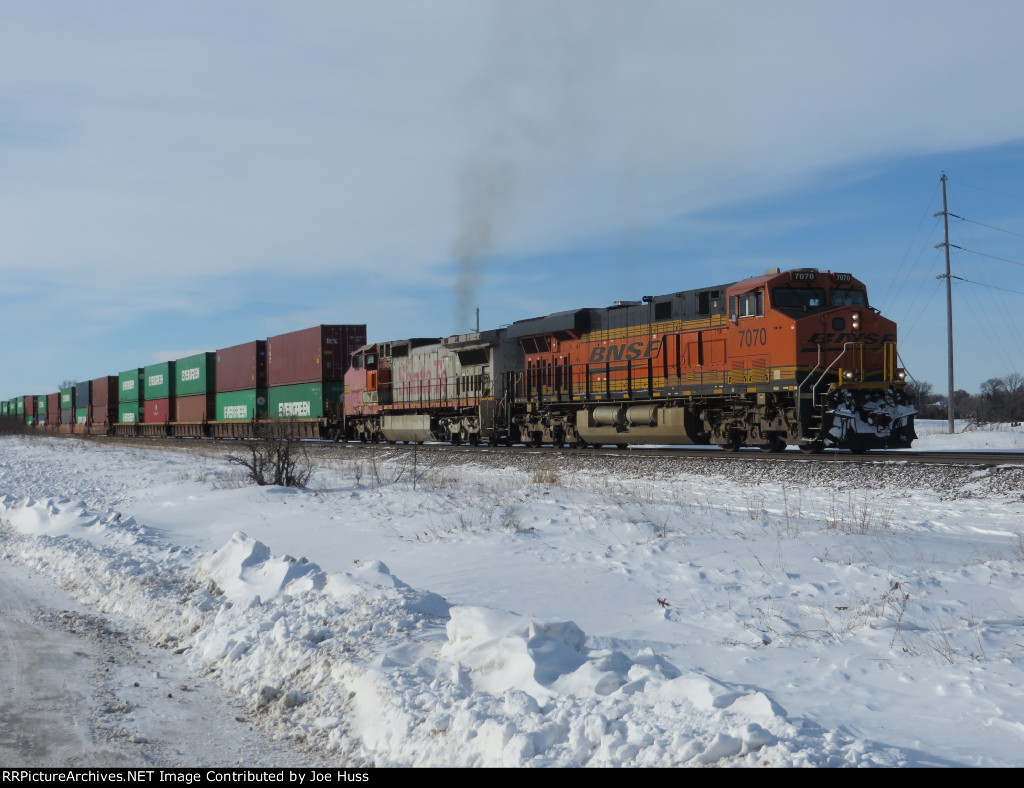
[2,268,916,452]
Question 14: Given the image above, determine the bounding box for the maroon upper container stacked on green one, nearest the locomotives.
[266,325,367,386]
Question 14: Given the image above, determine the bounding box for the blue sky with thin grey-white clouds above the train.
[0,0,1024,398]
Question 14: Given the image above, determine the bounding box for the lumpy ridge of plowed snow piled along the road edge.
[0,496,913,767]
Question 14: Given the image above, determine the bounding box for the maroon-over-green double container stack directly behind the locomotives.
[266,325,367,419]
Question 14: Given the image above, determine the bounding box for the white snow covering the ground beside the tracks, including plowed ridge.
[0,423,1024,767]
